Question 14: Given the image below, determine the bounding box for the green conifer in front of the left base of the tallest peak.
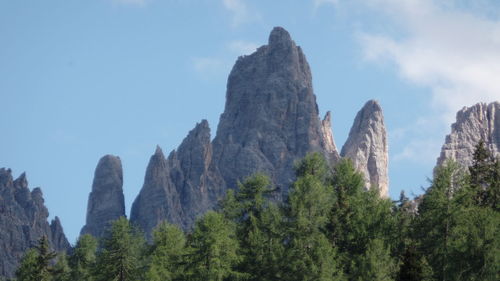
[222,174,283,281]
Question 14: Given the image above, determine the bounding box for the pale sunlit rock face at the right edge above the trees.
[437,102,500,167]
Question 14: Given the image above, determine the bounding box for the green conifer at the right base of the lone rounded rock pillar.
[95,217,145,281]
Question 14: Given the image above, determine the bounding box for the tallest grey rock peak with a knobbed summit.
[213,27,332,194]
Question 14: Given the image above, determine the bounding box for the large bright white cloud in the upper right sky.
[359,0,500,123]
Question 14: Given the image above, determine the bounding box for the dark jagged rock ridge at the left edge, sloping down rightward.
[0,168,70,277]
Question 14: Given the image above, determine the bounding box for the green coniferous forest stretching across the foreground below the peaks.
[9,142,500,281]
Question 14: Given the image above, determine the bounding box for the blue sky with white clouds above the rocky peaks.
[0,0,500,242]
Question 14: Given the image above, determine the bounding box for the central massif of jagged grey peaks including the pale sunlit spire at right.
[131,27,387,236]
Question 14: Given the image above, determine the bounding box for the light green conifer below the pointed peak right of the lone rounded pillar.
[146,222,186,281]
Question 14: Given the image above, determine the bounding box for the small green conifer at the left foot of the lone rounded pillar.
[69,234,97,281]
